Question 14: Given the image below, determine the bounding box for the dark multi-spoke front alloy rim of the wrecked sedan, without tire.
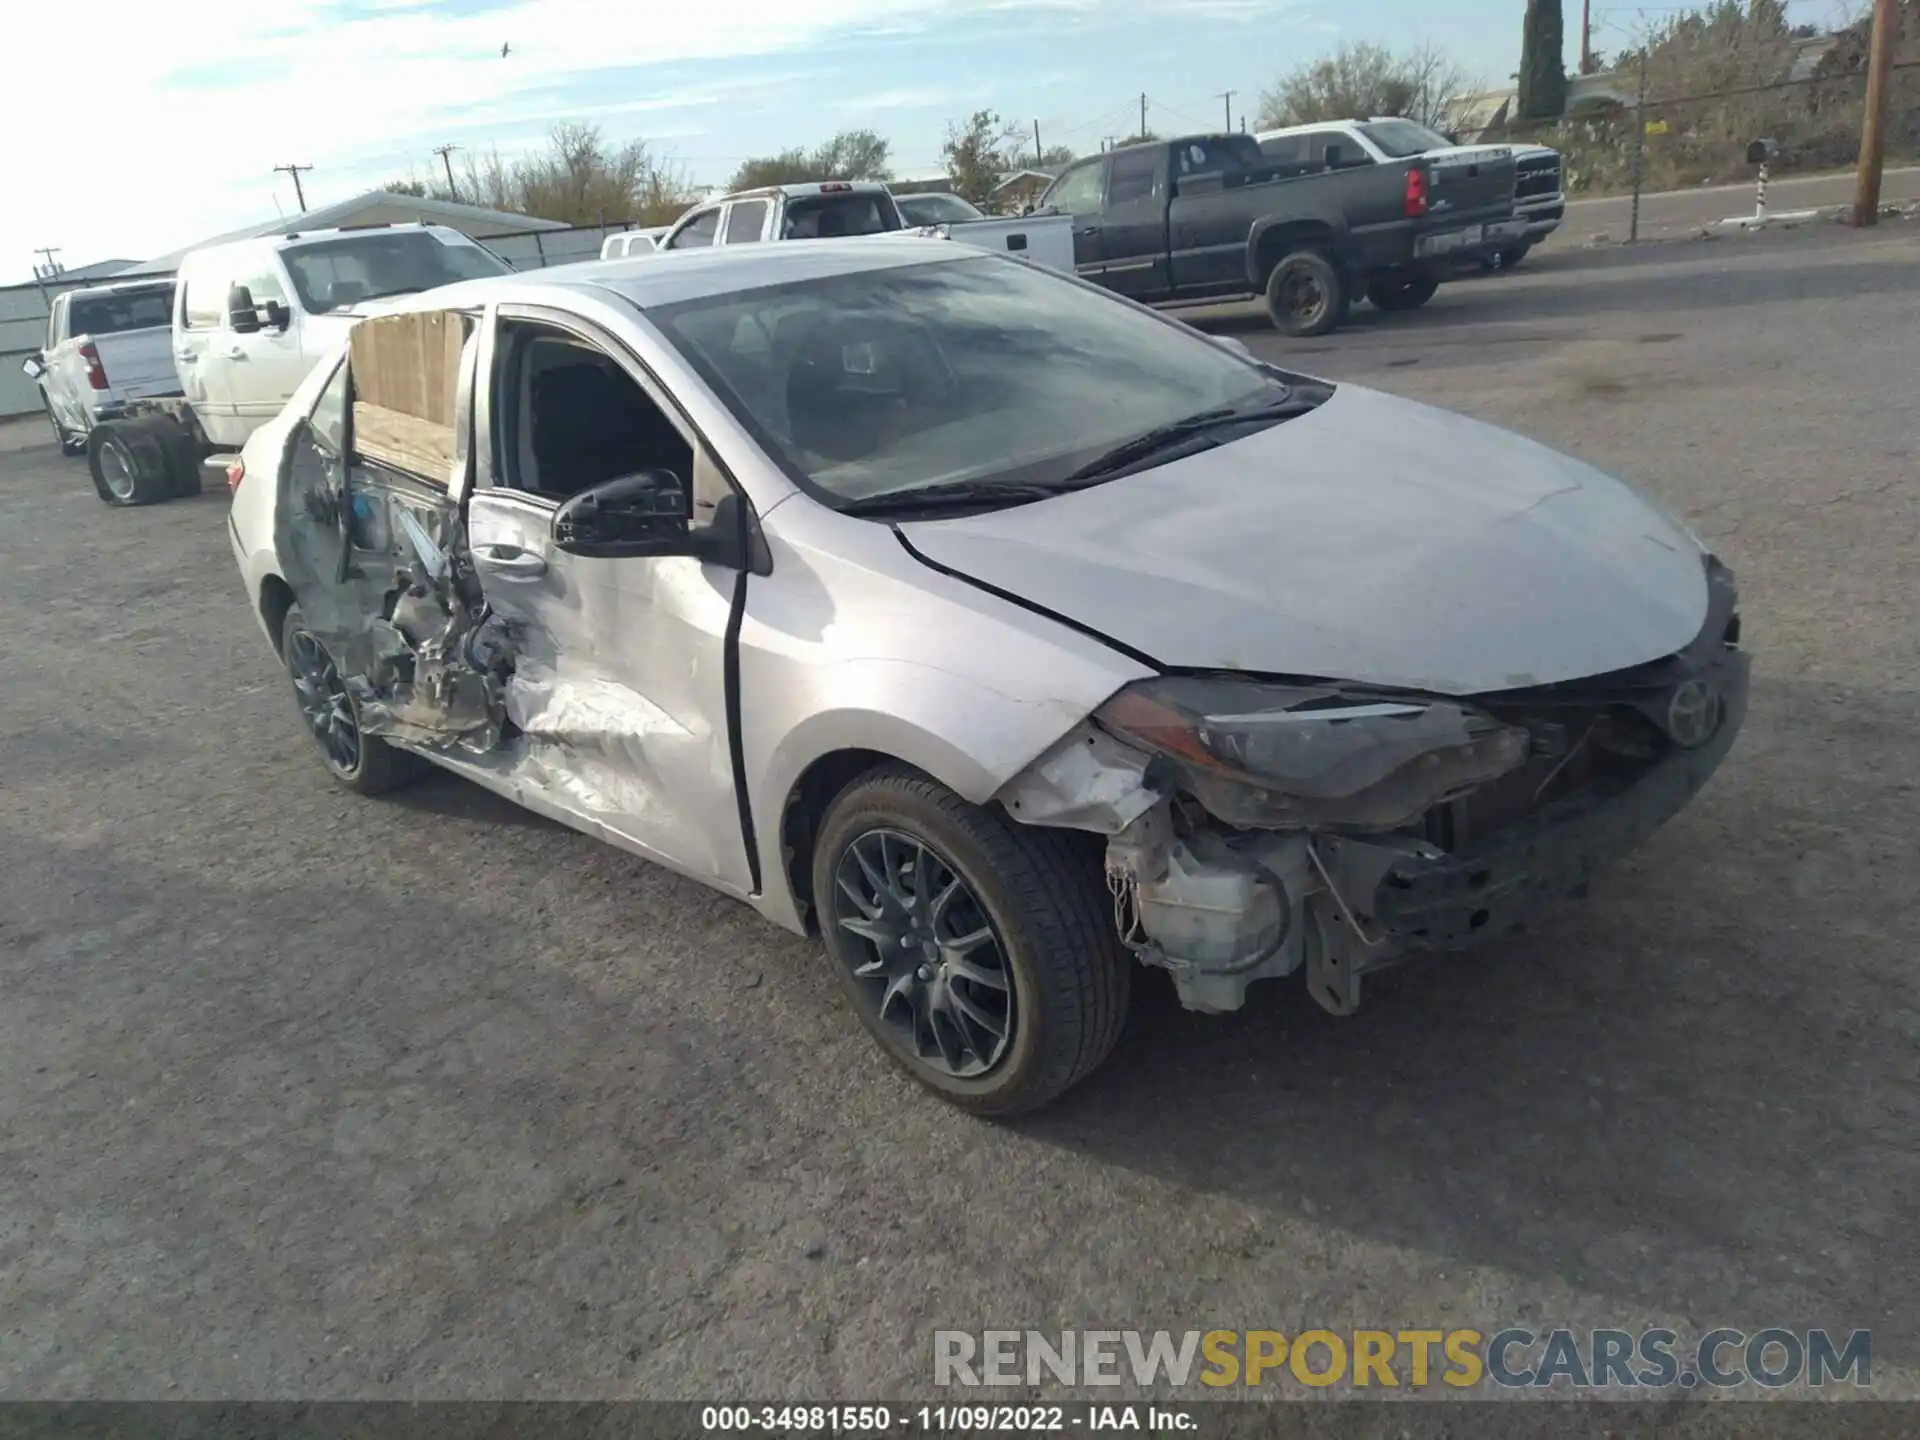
[833,829,1018,1079]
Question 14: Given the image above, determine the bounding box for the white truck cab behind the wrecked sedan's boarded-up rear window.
[173,225,513,449]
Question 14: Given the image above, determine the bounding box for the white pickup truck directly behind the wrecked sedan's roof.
[622,180,1075,275]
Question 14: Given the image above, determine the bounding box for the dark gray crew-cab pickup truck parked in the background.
[1037,134,1526,336]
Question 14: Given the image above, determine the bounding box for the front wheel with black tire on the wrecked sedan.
[812,766,1131,1116]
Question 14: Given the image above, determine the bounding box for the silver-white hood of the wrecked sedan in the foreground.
[899,386,1707,695]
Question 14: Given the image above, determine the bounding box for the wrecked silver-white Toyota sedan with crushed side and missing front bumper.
[232,240,1747,1114]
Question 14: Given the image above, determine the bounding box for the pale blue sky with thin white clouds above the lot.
[0,0,1843,284]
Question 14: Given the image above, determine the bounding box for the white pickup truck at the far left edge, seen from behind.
[21,280,179,455]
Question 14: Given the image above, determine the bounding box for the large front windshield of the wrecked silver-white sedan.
[647,255,1286,503]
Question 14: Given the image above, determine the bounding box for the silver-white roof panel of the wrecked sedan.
[382,232,975,313]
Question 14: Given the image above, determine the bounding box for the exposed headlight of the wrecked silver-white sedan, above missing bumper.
[1094,676,1530,829]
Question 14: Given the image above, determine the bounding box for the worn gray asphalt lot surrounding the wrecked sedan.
[0,230,1920,1432]
